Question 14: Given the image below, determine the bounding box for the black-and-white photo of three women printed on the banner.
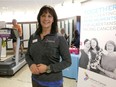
[79,38,116,80]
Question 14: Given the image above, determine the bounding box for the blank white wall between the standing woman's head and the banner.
[55,2,81,19]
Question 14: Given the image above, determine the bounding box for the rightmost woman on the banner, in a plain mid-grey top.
[97,41,116,79]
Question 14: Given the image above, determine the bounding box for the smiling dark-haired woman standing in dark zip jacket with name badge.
[26,5,71,87]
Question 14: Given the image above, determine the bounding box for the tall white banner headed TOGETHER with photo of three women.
[77,0,116,87]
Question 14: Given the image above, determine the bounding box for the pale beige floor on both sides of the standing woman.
[0,65,77,87]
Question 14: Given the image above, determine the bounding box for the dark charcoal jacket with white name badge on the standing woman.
[26,33,71,81]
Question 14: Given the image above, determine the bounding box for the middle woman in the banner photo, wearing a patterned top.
[90,38,102,73]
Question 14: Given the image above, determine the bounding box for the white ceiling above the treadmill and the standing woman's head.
[0,0,86,12]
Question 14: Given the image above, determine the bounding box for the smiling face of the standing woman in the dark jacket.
[40,12,54,28]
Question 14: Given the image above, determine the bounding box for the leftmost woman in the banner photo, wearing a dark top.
[79,39,91,69]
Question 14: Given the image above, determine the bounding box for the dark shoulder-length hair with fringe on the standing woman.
[37,5,58,34]
